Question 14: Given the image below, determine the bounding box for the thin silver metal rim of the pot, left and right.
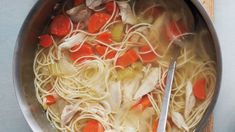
[12,0,222,132]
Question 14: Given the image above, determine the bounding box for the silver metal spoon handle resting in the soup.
[157,59,176,132]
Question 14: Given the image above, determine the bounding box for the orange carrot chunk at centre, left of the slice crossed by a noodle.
[116,49,138,68]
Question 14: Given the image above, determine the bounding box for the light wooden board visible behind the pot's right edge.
[200,0,214,132]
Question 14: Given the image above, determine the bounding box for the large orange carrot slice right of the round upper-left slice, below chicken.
[88,12,111,33]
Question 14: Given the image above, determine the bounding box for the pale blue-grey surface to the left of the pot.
[0,0,35,132]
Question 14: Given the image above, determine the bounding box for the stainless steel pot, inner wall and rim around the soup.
[13,0,222,132]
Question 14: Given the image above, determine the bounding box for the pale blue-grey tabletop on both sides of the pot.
[0,0,235,132]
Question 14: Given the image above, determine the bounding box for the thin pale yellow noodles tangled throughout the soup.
[33,1,216,132]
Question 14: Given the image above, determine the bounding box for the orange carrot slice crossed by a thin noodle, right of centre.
[139,45,157,63]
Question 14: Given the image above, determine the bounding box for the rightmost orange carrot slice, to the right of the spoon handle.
[193,78,206,100]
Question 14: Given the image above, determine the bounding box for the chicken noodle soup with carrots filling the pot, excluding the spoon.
[33,0,216,132]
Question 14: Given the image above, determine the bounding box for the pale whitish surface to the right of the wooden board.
[214,0,235,132]
